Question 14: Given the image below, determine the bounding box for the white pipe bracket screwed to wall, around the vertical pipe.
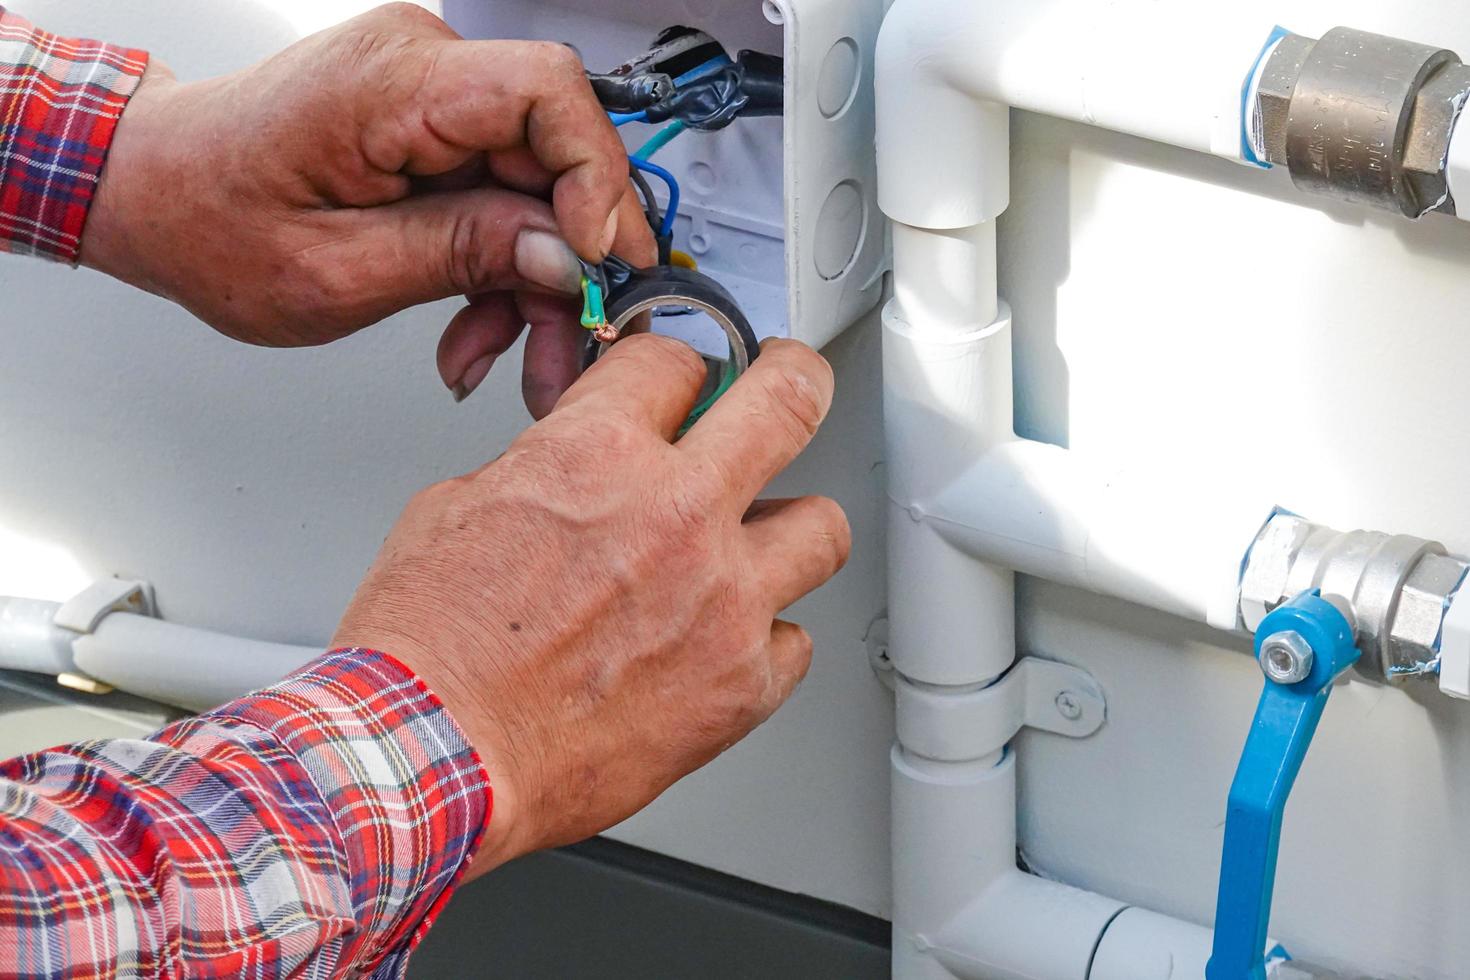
[895,657,1107,761]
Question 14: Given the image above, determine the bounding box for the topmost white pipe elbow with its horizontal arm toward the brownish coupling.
[876,0,1274,228]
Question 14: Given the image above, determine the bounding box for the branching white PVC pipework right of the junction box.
[875,0,1299,980]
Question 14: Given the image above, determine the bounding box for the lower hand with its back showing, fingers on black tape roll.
[332,335,850,871]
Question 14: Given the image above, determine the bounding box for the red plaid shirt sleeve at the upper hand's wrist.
[0,6,148,262]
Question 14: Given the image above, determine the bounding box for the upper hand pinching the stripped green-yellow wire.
[82,3,654,417]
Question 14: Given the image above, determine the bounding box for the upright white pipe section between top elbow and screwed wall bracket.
[883,222,1016,685]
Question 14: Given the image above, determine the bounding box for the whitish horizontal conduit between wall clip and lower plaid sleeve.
[72,613,323,711]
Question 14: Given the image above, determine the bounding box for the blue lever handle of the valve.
[1205,591,1360,980]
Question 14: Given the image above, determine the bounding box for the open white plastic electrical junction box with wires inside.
[442,0,888,347]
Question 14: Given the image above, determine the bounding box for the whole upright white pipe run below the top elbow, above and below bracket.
[883,213,1017,980]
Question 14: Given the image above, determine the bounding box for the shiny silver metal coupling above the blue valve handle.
[1241,513,1470,682]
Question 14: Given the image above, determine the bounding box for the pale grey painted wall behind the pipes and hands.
[0,0,1470,980]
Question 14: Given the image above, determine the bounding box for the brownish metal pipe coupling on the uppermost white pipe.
[1255,28,1470,217]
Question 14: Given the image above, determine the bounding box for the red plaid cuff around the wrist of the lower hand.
[204,649,491,976]
